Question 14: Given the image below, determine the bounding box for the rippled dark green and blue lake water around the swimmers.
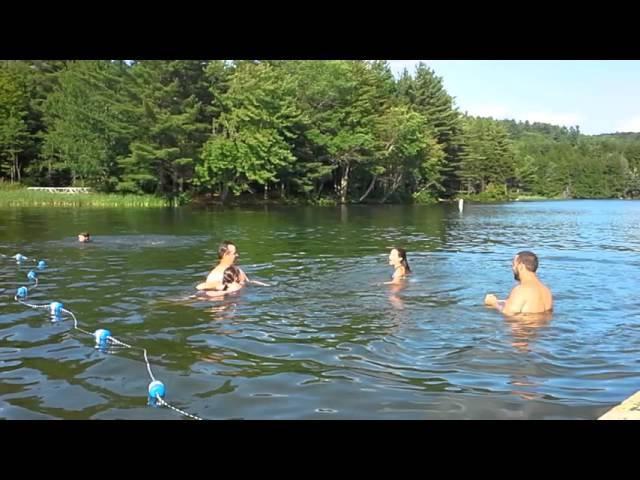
[0,200,640,420]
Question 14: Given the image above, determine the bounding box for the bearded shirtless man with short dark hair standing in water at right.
[484,252,553,315]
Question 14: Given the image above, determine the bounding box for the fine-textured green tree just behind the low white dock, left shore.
[42,60,137,191]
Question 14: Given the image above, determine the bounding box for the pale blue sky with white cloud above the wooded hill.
[389,60,640,134]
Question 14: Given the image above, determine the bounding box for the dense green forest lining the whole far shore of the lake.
[0,60,640,204]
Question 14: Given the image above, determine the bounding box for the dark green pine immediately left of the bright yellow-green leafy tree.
[118,60,211,202]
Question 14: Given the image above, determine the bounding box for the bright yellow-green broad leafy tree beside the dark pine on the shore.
[196,63,300,199]
